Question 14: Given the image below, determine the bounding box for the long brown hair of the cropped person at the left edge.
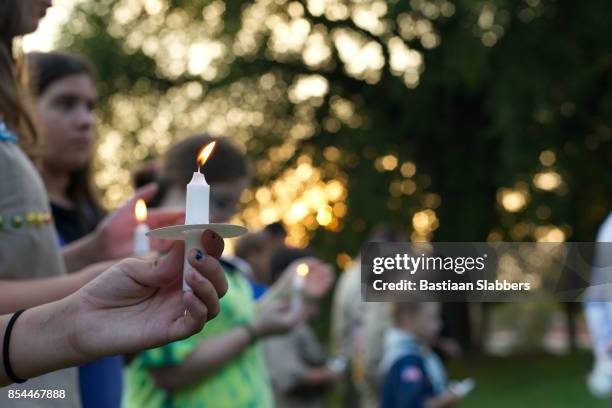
[0,0,36,154]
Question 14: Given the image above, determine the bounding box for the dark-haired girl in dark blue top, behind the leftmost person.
[27,52,118,408]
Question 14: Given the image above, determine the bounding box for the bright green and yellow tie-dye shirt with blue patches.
[123,262,274,408]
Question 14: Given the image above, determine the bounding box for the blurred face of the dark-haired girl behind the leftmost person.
[36,74,97,172]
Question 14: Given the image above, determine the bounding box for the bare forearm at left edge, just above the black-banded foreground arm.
[0,262,114,314]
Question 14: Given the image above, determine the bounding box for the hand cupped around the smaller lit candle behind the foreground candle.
[94,184,185,260]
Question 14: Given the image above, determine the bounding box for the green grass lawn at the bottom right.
[448,352,612,408]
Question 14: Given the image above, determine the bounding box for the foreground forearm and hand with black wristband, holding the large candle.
[0,231,227,387]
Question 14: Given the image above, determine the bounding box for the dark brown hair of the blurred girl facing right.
[26,52,104,226]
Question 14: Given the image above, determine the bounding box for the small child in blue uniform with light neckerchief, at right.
[380,302,460,408]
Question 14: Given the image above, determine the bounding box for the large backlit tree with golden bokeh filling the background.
[60,0,612,346]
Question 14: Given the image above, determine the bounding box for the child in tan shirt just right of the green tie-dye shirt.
[265,247,341,408]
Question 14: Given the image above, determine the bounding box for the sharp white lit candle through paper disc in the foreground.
[183,142,217,291]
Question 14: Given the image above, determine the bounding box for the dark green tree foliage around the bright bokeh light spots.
[61,0,612,259]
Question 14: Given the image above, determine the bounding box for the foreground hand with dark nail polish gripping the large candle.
[66,231,228,359]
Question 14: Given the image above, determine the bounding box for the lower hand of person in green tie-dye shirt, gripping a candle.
[253,300,304,337]
